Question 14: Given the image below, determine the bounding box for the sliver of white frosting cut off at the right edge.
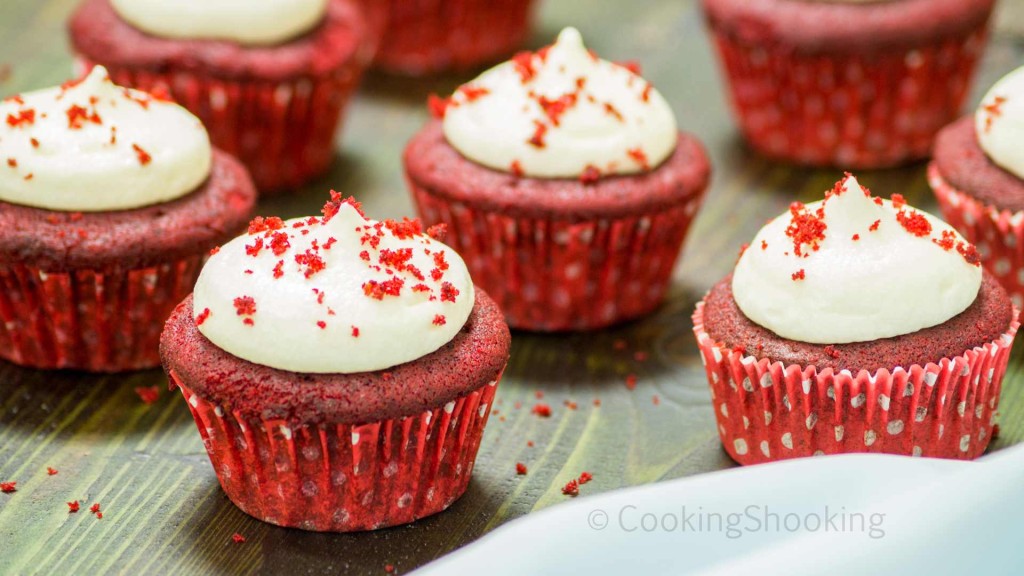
[974,67,1024,178]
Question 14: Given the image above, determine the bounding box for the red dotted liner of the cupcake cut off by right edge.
[928,162,1024,307]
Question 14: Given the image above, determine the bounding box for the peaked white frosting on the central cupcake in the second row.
[443,28,678,178]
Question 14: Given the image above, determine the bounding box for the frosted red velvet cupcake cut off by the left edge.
[0,68,256,372]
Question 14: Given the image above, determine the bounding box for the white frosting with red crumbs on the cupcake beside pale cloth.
[732,176,981,344]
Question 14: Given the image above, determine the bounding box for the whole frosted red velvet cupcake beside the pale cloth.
[693,176,1019,464]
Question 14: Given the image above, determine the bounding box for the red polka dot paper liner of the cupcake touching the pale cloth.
[693,301,1020,464]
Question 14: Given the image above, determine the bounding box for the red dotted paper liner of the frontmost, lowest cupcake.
[169,370,501,532]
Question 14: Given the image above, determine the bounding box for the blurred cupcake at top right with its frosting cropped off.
[702,0,994,168]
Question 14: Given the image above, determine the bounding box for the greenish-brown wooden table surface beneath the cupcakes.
[0,0,1024,574]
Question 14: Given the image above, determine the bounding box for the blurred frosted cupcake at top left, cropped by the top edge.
[69,0,371,193]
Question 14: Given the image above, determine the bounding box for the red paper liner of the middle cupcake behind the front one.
[410,180,703,331]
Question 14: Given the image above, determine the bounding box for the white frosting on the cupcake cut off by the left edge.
[0,67,212,212]
